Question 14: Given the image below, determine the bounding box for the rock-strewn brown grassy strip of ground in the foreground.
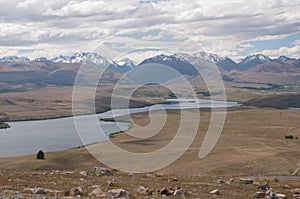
[0,167,300,199]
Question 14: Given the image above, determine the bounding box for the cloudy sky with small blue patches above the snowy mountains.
[0,0,300,59]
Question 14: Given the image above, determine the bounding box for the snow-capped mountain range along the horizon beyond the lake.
[0,52,300,91]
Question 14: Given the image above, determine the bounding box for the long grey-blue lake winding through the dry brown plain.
[0,99,239,157]
